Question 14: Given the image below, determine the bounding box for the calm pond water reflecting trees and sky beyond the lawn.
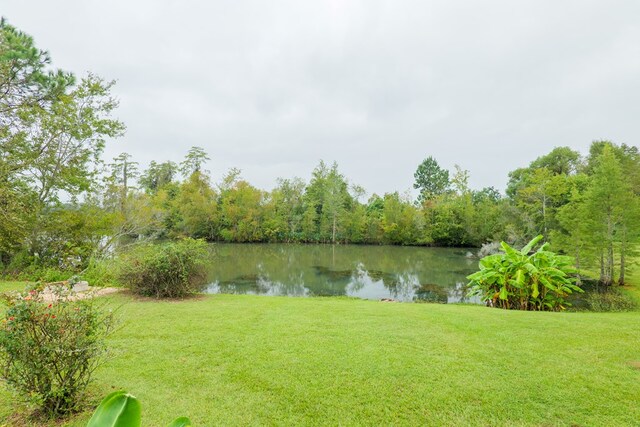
[207,244,478,303]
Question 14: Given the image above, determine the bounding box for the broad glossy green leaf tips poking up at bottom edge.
[87,391,191,427]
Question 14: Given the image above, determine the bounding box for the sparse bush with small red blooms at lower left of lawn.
[0,287,113,417]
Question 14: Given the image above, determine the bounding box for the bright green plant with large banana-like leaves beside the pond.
[467,236,583,310]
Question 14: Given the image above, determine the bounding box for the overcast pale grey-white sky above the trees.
[0,0,640,194]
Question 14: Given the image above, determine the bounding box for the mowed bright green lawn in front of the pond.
[0,285,640,427]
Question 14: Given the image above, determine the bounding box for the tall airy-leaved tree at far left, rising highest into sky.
[0,20,124,266]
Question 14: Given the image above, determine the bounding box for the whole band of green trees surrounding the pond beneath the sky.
[0,20,640,284]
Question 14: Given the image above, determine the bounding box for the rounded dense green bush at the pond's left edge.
[118,239,209,298]
